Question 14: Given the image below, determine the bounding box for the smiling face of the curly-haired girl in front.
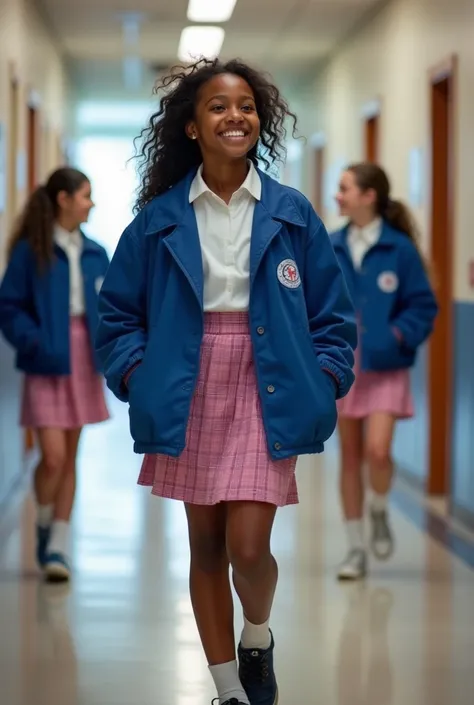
[186,74,260,161]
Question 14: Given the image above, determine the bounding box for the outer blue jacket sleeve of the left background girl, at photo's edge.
[0,241,40,353]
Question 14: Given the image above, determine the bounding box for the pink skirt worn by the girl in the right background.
[337,348,414,419]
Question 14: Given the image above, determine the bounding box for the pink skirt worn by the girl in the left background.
[20,316,109,429]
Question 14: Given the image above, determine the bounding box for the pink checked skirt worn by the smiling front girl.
[138,313,298,506]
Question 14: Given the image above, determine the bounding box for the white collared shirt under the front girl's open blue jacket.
[189,162,262,312]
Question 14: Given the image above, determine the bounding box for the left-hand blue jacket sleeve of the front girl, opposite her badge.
[95,223,147,401]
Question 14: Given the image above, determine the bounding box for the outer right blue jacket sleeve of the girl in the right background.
[391,241,438,350]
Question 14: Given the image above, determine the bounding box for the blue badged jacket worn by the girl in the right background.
[331,222,438,371]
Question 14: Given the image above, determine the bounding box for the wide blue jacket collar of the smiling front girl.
[145,168,305,236]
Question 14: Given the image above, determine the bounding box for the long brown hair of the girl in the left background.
[8,167,89,268]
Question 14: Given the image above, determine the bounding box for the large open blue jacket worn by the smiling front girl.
[96,171,356,459]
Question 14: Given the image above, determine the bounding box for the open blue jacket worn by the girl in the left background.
[0,235,109,375]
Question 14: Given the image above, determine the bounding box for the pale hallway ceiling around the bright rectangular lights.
[37,0,382,97]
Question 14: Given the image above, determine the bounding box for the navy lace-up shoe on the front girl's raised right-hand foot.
[239,632,278,705]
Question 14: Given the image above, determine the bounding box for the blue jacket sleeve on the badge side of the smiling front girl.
[304,211,357,398]
